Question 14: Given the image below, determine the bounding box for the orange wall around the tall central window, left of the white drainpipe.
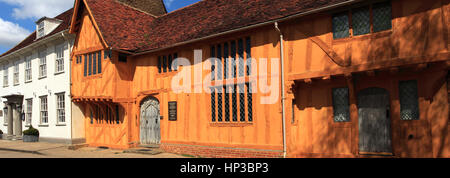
[131,28,282,151]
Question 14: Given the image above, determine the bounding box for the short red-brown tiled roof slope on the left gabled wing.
[86,0,155,51]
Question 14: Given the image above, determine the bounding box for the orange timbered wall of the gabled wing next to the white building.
[72,4,132,148]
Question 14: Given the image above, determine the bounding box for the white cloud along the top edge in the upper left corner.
[0,0,74,19]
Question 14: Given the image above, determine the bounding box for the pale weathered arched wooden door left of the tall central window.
[140,97,161,145]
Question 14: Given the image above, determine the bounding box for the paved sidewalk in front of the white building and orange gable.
[0,140,185,158]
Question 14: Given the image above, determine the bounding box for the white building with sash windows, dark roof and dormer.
[0,9,84,144]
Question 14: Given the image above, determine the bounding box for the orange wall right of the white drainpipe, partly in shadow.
[282,0,450,157]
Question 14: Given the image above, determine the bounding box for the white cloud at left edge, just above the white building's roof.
[0,18,30,48]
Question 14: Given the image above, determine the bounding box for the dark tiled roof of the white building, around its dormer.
[0,9,73,57]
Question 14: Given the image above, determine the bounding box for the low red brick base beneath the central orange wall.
[160,143,283,158]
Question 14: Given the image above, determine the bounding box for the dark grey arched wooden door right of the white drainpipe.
[358,88,392,154]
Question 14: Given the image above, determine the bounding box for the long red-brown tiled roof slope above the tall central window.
[137,0,349,51]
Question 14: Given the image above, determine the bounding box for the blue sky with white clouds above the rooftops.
[0,0,200,54]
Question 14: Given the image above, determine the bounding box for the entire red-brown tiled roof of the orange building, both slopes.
[74,0,352,53]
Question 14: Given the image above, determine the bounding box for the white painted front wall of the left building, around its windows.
[0,35,73,143]
